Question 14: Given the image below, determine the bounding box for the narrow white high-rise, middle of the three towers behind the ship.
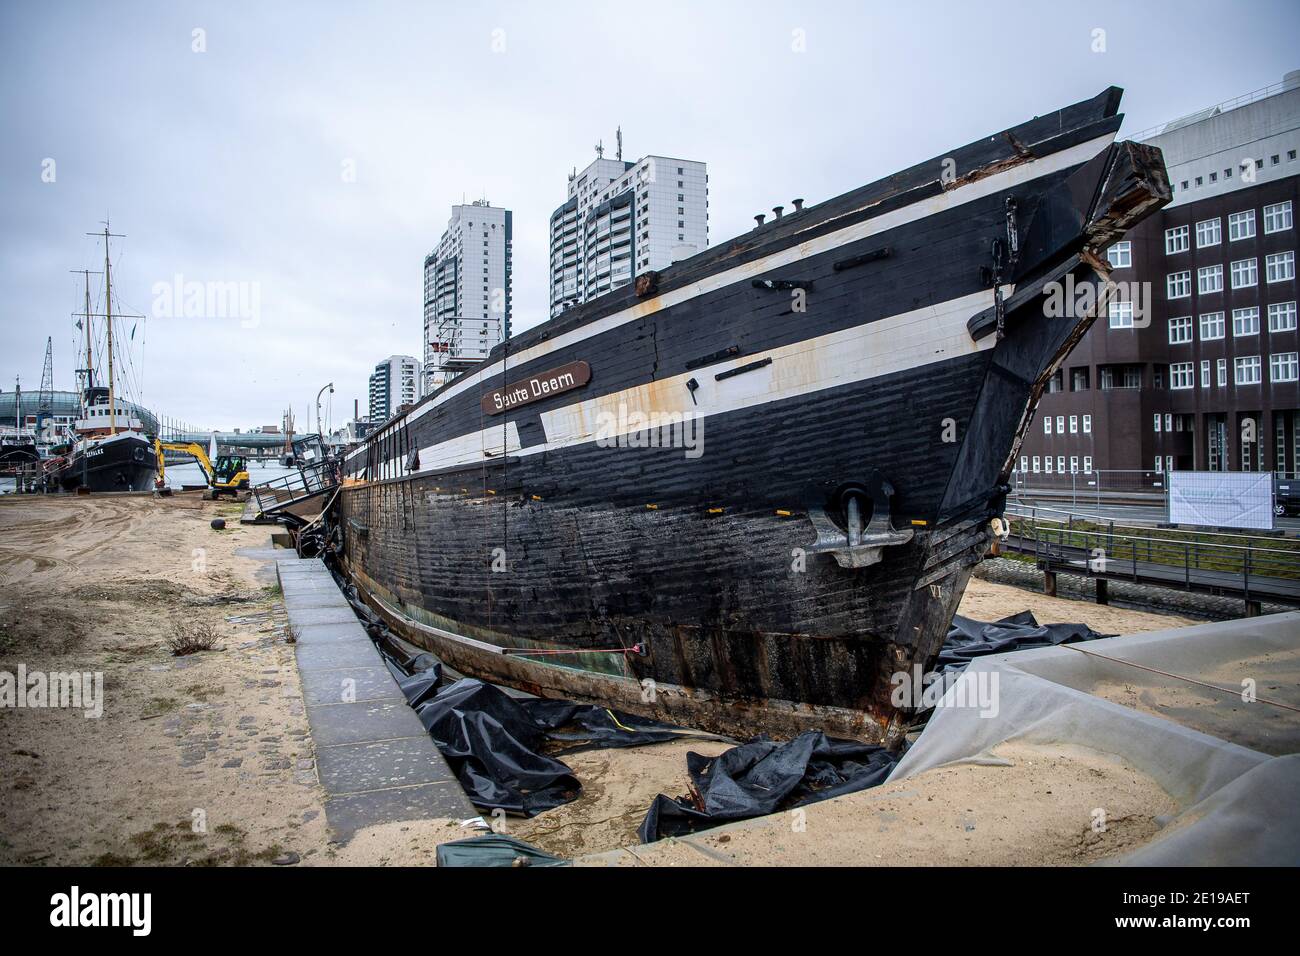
[424,199,514,394]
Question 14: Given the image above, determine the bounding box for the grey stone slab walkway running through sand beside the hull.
[276,550,478,840]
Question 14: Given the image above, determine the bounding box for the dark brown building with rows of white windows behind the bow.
[1017,70,1300,484]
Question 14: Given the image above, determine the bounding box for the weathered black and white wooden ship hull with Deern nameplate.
[337,88,1170,740]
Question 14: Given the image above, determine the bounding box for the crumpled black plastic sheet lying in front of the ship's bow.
[637,731,897,843]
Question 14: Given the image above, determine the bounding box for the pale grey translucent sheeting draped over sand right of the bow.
[888,613,1300,866]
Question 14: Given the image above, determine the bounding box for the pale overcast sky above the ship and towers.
[0,0,1300,428]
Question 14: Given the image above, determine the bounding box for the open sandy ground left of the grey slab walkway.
[0,494,328,865]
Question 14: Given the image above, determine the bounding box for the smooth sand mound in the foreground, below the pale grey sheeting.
[581,743,1178,866]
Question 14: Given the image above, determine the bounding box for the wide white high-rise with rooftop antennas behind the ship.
[550,147,709,317]
